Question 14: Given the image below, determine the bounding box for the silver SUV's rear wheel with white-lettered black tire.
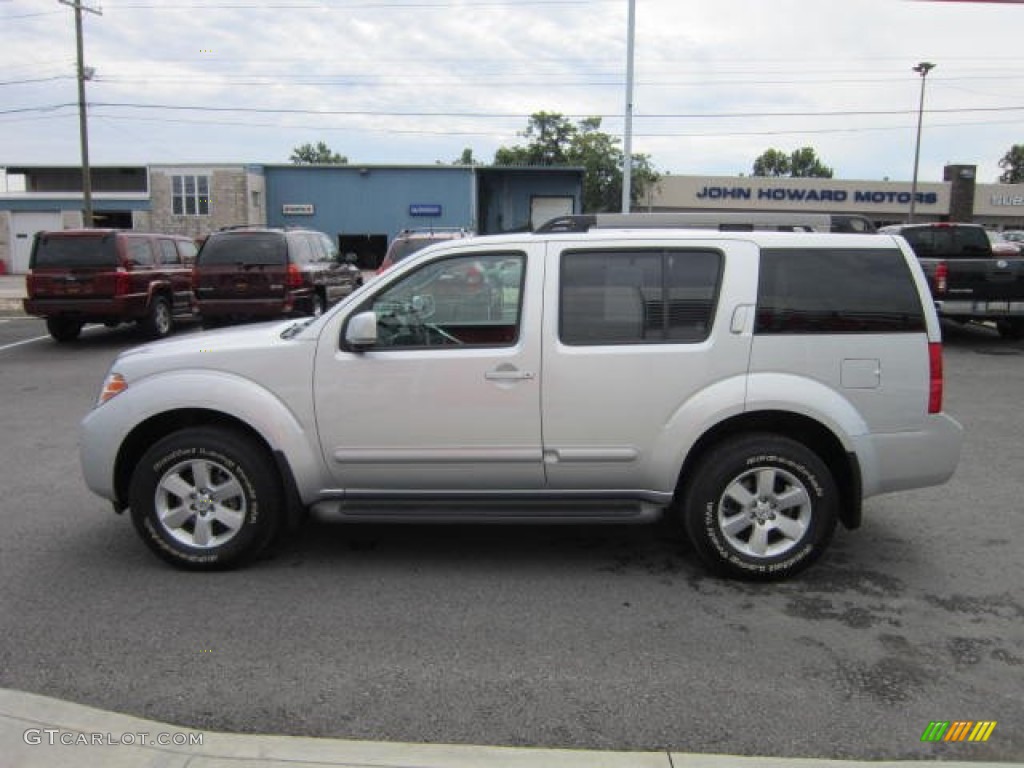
[682,434,839,581]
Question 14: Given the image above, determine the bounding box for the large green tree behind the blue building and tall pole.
[495,112,660,213]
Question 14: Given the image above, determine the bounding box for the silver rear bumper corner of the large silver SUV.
[855,414,964,499]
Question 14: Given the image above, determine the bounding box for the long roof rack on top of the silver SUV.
[534,211,876,233]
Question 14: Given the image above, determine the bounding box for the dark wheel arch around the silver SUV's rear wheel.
[676,411,862,529]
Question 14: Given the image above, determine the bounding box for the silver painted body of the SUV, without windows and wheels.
[81,229,962,520]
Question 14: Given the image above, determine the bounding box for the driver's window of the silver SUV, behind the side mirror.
[366,253,525,348]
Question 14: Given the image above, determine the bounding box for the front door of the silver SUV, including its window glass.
[314,242,544,495]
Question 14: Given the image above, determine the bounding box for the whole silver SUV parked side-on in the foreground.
[81,219,962,580]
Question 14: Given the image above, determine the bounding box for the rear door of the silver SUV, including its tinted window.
[542,239,757,494]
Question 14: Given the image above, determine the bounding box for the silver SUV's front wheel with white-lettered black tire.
[129,427,284,570]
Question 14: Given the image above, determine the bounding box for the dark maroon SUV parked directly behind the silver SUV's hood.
[193,227,362,326]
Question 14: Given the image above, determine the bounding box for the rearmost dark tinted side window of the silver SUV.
[755,248,925,334]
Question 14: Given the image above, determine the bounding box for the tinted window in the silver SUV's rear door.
[559,249,722,345]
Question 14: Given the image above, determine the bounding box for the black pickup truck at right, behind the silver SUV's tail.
[882,222,1024,339]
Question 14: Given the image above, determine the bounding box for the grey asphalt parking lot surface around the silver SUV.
[0,311,1024,761]
